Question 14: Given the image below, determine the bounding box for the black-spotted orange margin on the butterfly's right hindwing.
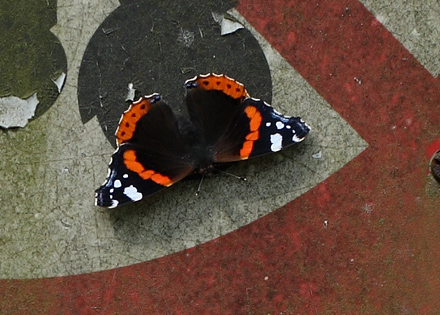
[196,74,249,99]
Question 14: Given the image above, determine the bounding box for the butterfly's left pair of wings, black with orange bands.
[96,94,194,208]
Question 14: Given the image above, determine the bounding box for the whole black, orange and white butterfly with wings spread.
[96,74,310,208]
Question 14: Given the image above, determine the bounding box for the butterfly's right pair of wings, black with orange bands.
[185,74,310,162]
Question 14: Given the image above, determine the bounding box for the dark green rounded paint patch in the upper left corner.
[0,0,67,121]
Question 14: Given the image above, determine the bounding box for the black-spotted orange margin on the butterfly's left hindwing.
[116,97,151,146]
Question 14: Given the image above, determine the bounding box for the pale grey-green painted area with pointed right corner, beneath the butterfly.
[0,3,367,278]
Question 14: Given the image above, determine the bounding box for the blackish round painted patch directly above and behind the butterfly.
[78,0,272,145]
